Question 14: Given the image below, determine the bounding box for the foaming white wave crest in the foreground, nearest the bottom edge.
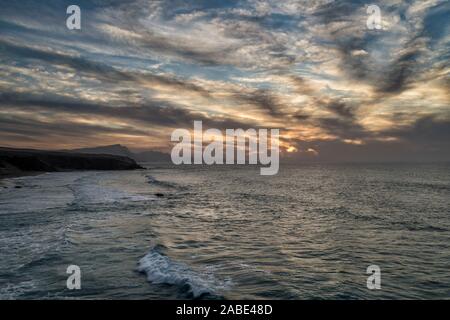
[138,246,226,298]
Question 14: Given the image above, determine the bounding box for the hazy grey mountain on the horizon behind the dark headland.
[70,144,170,162]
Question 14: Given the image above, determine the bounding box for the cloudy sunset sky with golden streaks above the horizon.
[0,0,450,161]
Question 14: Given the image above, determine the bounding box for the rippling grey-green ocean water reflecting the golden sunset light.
[0,164,450,299]
